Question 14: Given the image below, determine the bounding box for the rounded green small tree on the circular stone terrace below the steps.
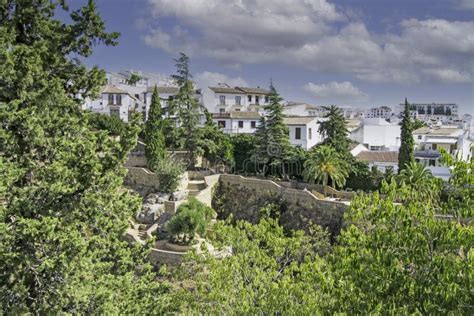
[166,197,215,243]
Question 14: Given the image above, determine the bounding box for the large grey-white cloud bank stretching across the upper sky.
[144,0,474,84]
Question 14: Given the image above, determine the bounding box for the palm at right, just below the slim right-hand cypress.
[398,161,439,200]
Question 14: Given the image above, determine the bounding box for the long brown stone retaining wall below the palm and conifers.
[212,175,348,236]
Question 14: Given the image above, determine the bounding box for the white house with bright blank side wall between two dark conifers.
[283,116,323,150]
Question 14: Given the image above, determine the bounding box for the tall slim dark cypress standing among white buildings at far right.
[398,98,415,173]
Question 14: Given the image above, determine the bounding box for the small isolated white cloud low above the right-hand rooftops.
[303,81,369,101]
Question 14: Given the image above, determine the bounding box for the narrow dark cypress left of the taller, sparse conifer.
[145,86,166,171]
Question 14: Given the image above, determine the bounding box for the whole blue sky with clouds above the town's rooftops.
[74,0,474,114]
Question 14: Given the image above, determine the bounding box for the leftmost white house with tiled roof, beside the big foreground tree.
[83,85,144,122]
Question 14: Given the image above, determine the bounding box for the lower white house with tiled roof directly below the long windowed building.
[212,111,261,135]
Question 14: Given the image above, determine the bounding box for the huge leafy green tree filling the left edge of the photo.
[0,0,167,314]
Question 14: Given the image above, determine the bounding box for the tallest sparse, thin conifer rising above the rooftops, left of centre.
[170,53,202,168]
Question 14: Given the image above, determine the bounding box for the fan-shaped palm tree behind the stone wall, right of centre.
[303,145,349,193]
